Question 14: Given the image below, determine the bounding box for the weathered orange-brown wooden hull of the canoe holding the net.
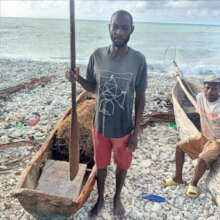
[13,92,96,219]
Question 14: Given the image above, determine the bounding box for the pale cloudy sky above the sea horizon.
[0,0,220,25]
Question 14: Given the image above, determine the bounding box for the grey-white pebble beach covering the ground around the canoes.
[0,59,220,220]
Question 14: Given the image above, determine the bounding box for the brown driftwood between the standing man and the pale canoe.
[141,112,175,127]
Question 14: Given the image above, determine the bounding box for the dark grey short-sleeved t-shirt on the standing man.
[86,47,147,138]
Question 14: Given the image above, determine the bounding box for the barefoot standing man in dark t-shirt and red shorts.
[67,10,147,219]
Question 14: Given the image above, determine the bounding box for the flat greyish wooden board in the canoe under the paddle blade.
[36,160,87,201]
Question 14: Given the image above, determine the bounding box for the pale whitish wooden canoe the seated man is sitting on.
[172,76,220,206]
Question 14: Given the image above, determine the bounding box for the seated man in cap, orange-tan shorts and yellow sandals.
[162,76,220,198]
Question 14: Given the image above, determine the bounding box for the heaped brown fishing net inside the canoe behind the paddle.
[53,99,96,167]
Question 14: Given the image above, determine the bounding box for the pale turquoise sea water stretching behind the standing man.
[0,17,220,75]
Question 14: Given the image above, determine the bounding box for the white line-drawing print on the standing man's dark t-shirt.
[98,70,133,116]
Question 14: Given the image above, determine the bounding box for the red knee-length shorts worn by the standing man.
[92,128,132,170]
